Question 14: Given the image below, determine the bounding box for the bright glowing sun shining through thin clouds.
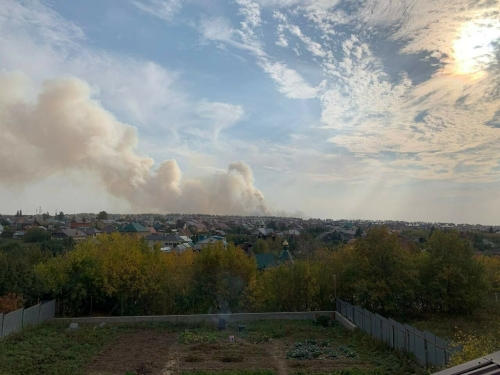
[453,19,500,79]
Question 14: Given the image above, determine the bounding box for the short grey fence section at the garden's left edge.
[0,300,56,338]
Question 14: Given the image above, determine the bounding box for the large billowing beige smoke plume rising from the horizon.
[0,73,270,215]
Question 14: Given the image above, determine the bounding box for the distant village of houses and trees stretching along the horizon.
[0,213,500,270]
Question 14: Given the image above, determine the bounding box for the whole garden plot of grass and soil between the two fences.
[0,321,424,375]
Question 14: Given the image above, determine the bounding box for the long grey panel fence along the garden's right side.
[336,299,457,367]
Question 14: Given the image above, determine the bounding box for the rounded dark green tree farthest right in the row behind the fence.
[420,231,487,313]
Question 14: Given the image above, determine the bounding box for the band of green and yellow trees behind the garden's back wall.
[0,228,500,316]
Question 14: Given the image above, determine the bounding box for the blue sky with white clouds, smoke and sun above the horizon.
[0,0,500,225]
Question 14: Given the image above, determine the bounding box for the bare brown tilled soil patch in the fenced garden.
[86,330,372,375]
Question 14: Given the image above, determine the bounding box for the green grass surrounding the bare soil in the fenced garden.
[0,321,424,375]
